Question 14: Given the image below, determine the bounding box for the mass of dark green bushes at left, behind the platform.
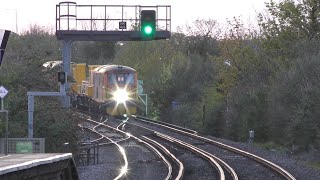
[0,26,76,152]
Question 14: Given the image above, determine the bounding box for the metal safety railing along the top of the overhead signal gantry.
[56,2,171,31]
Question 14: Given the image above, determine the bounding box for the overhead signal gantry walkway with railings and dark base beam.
[56,2,171,41]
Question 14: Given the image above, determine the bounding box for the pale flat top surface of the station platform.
[0,153,72,175]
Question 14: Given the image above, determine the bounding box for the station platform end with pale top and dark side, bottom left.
[0,153,79,180]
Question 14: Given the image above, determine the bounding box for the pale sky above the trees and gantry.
[0,0,270,33]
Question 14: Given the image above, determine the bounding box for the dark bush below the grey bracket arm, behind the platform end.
[34,97,78,152]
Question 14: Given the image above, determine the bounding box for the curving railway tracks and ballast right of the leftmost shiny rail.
[74,111,295,180]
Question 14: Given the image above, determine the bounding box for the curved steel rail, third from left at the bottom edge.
[142,136,184,180]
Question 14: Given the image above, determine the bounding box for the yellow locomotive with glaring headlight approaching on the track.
[71,64,138,115]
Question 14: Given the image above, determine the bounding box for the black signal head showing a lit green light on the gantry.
[141,10,157,40]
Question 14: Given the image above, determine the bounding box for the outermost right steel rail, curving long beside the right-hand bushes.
[135,116,296,180]
